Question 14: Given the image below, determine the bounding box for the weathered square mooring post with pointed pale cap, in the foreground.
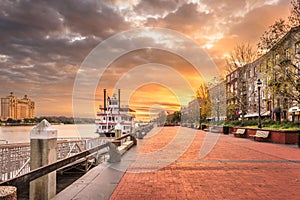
[29,119,57,200]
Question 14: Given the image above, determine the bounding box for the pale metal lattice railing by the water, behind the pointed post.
[0,138,108,182]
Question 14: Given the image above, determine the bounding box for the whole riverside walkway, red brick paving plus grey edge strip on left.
[54,127,300,200]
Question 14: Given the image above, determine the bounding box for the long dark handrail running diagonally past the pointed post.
[0,142,109,187]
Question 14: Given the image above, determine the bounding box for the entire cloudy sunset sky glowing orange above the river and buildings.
[0,0,290,119]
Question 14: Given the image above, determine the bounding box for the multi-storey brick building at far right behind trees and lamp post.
[226,26,300,120]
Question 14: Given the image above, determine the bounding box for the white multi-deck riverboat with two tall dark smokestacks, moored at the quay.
[95,89,135,137]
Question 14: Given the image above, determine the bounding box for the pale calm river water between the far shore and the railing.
[0,124,98,144]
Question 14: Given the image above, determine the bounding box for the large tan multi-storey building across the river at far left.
[1,92,34,120]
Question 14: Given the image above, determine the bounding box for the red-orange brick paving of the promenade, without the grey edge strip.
[110,127,300,200]
